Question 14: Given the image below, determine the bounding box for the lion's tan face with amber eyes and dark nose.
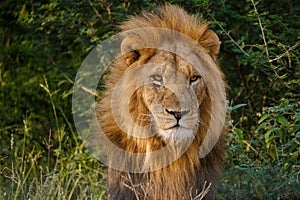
[134,51,207,143]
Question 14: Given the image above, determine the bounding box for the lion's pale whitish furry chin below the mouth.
[159,126,195,144]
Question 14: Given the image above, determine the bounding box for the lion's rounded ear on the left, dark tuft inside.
[121,36,141,66]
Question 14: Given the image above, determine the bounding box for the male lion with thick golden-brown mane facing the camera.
[97,4,226,199]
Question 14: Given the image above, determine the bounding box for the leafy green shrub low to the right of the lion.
[221,101,300,199]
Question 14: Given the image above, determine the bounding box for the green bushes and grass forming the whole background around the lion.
[0,0,300,199]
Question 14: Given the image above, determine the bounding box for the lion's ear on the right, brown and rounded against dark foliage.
[199,30,221,60]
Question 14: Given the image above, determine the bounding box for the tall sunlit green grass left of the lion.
[0,77,105,200]
